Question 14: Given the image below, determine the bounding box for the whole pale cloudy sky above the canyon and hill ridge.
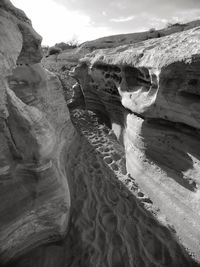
[11,0,200,46]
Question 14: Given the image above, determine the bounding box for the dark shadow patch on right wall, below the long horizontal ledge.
[141,119,200,192]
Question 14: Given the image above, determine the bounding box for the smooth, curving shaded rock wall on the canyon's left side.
[0,1,74,264]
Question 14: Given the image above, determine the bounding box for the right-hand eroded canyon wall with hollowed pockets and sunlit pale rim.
[71,27,200,266]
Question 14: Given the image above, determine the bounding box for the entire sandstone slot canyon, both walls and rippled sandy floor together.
[0,0,200,267]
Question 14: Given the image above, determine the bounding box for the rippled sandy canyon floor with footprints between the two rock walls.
[9,109,198,267]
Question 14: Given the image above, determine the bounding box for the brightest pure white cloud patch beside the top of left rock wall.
[11,0,110,45]
